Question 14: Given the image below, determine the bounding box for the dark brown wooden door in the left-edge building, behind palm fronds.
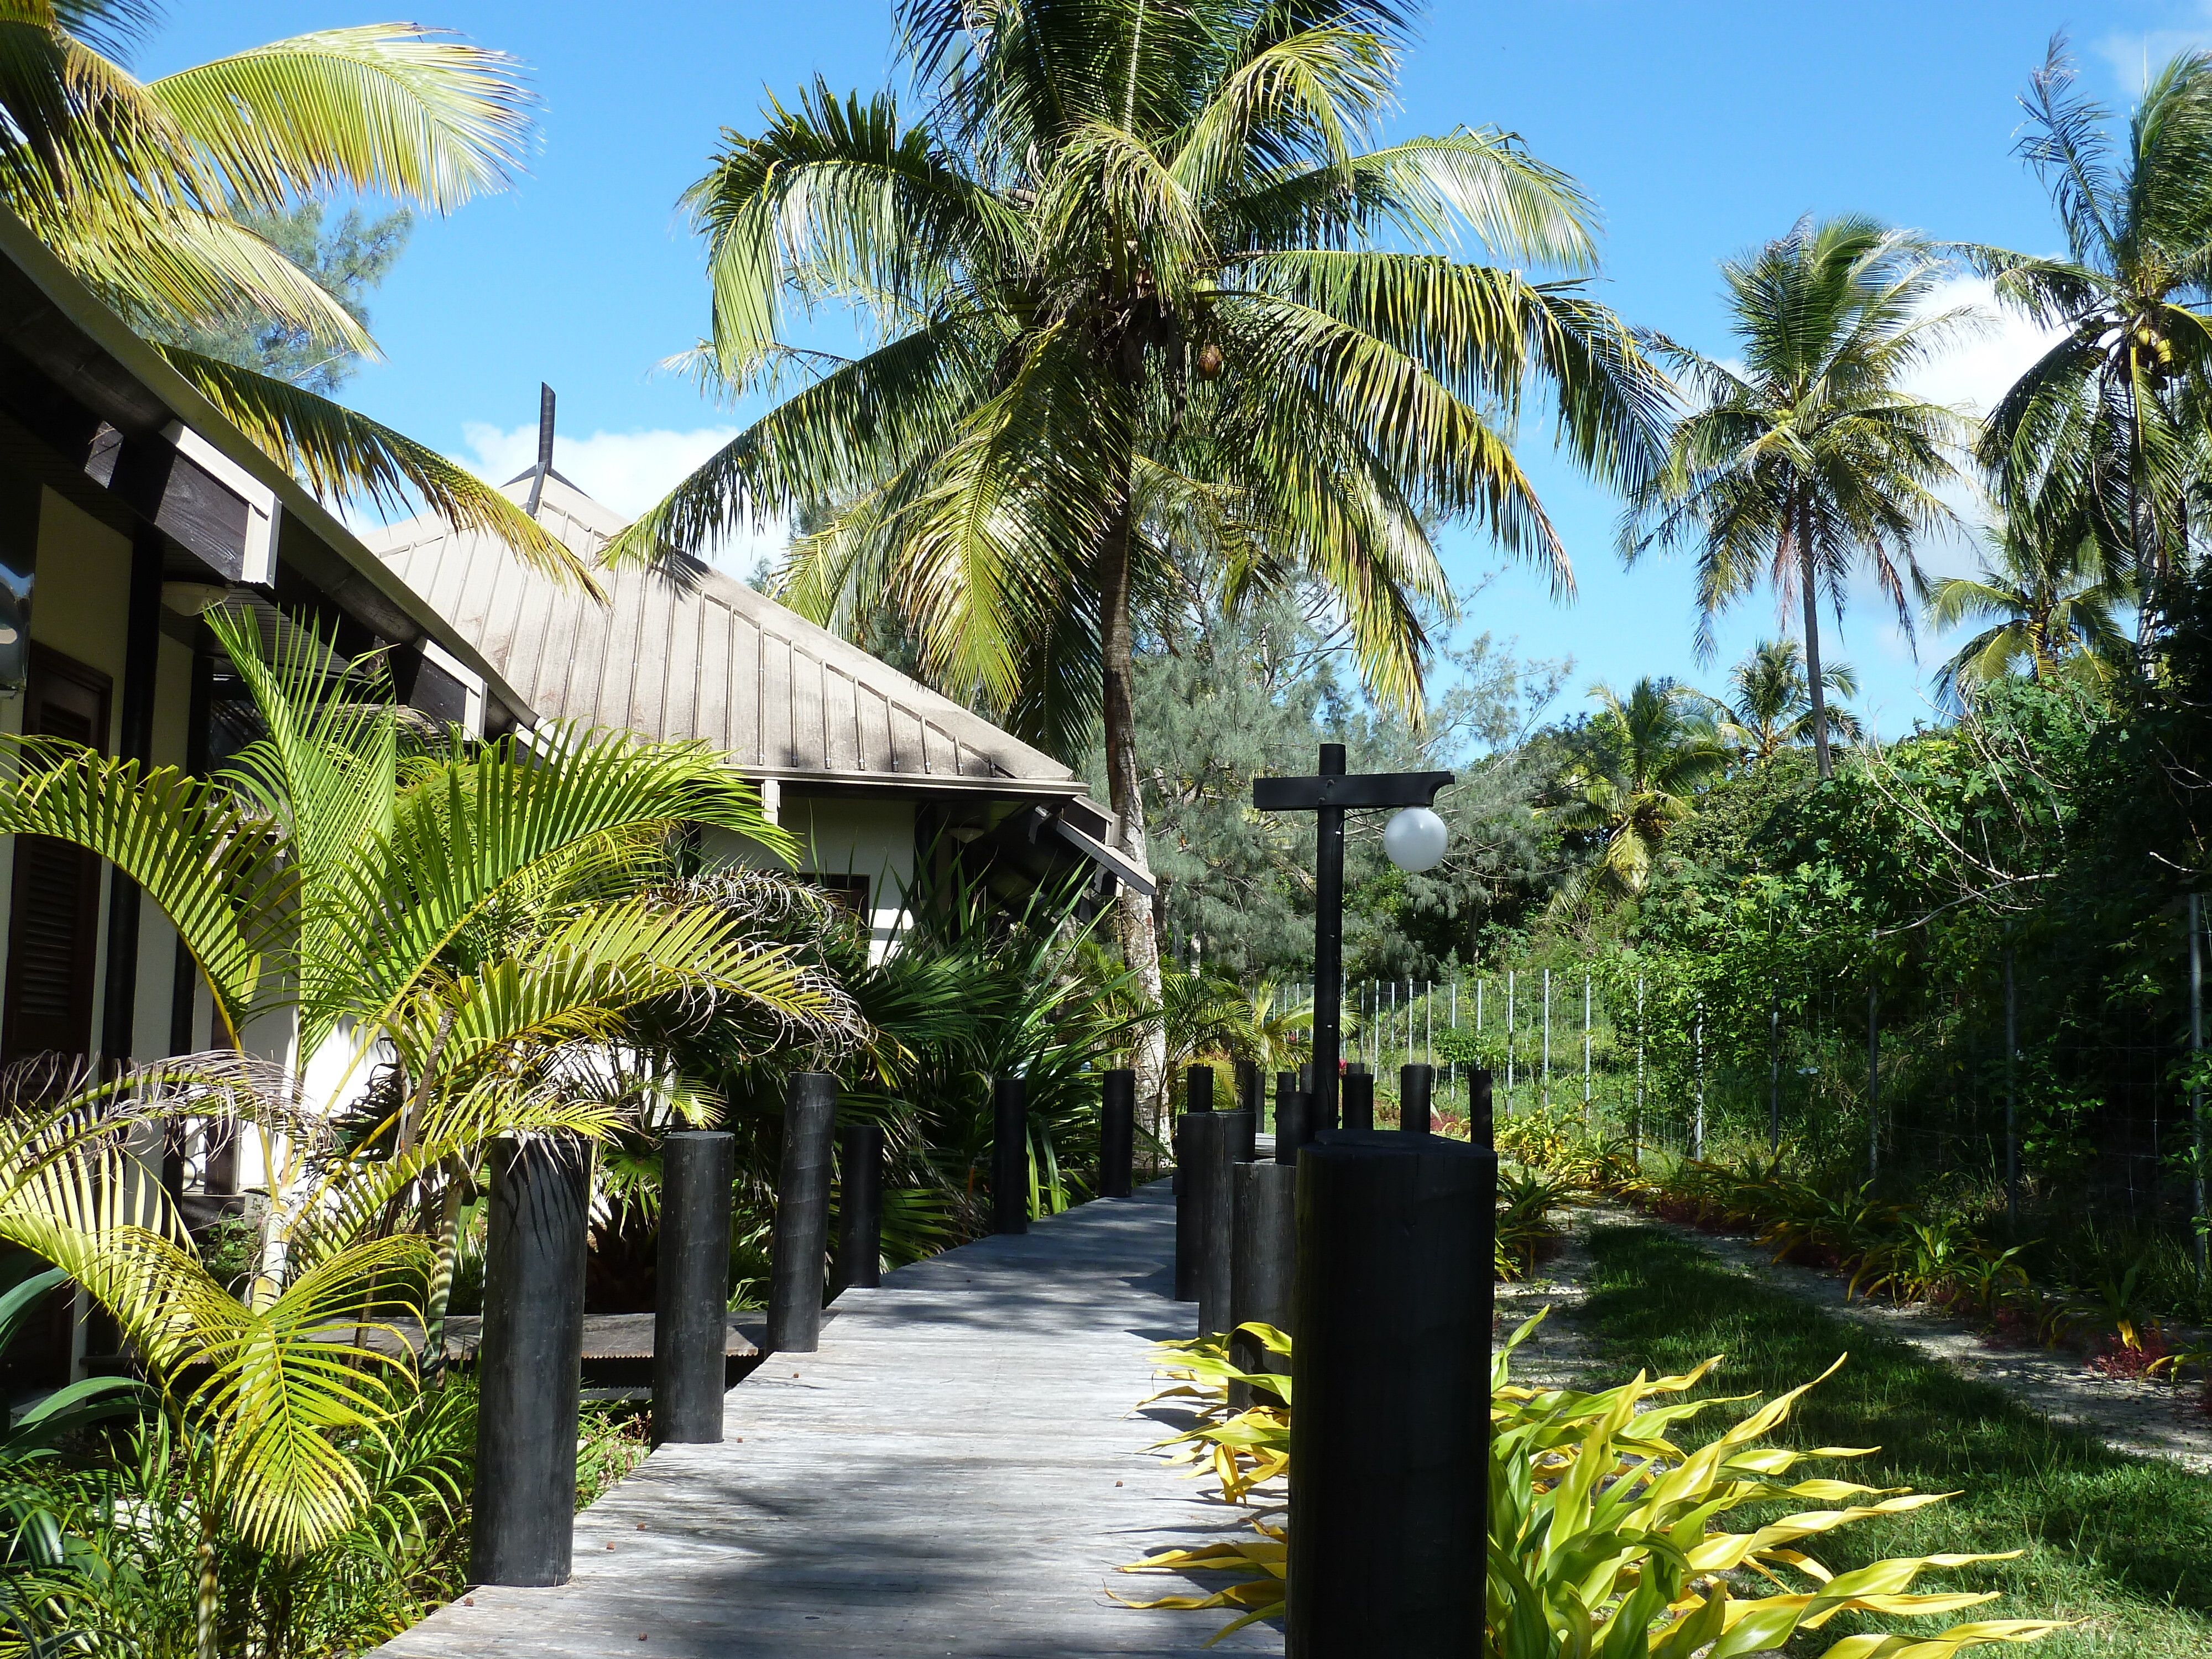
[0,646,108,1060]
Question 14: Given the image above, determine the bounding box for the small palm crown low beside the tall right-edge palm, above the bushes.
[1927,513,2132,703]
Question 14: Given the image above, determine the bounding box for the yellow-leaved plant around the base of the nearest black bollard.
[1124,1314,2062,1659]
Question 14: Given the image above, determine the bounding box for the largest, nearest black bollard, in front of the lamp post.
[1285,1130,1498,1659]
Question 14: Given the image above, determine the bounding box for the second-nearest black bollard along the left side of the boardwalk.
[653,1128,737,1447]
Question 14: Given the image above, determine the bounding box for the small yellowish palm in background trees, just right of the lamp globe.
[1551,677,1728,898]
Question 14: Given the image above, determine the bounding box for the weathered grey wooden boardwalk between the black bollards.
[378,1181,1283,1659]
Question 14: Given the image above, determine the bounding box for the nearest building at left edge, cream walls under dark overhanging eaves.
[0,212,526,1394]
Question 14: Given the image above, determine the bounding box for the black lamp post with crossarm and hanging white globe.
[1252,743,1451,1124]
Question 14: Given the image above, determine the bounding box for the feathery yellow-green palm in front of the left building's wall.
[0,613,849,1652]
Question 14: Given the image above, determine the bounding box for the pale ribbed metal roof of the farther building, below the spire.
[363,473,1084,799]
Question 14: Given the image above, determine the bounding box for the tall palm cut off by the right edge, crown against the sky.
[1962,35,2212,597]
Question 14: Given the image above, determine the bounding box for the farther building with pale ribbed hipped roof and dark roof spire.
[363,392,1152,949]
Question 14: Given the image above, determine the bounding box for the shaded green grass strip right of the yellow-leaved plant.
[1584,1228,2212,1659]
